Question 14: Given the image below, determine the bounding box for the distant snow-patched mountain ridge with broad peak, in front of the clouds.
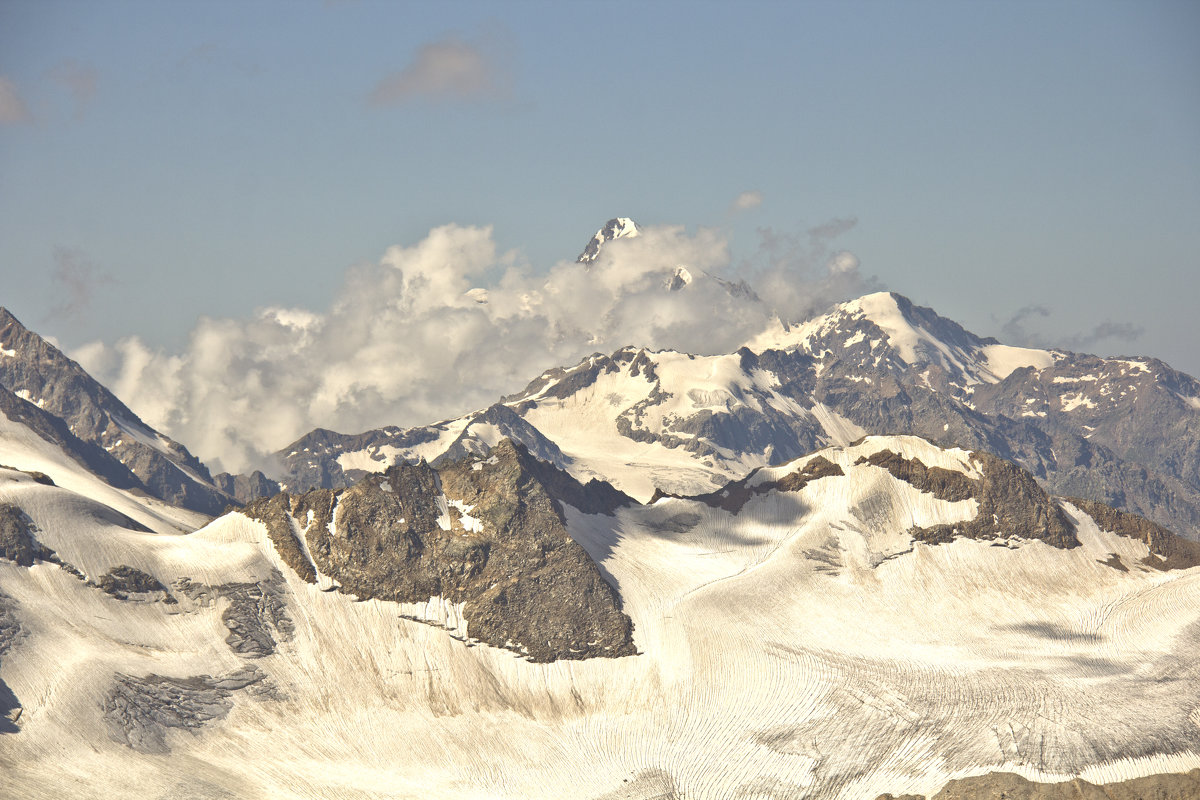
[270,287,1200,537]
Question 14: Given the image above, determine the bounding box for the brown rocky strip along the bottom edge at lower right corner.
[878,770,1200,800]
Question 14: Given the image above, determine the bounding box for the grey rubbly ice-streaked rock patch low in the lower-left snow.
[103,667,266,753]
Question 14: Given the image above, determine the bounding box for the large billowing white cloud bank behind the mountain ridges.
[71,224,871,471]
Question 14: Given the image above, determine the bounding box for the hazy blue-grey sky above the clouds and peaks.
[0,0,1200,462]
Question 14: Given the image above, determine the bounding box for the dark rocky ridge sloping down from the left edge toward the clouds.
[0,303,229,515]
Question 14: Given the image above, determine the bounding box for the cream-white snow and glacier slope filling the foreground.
[0,437,1200,800]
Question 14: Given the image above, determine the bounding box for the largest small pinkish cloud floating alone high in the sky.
[371,36,511,107]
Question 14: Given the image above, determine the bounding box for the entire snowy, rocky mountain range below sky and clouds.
[0,218,1200,800]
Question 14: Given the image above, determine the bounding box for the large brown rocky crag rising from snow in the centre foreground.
[247,439,635,661]
